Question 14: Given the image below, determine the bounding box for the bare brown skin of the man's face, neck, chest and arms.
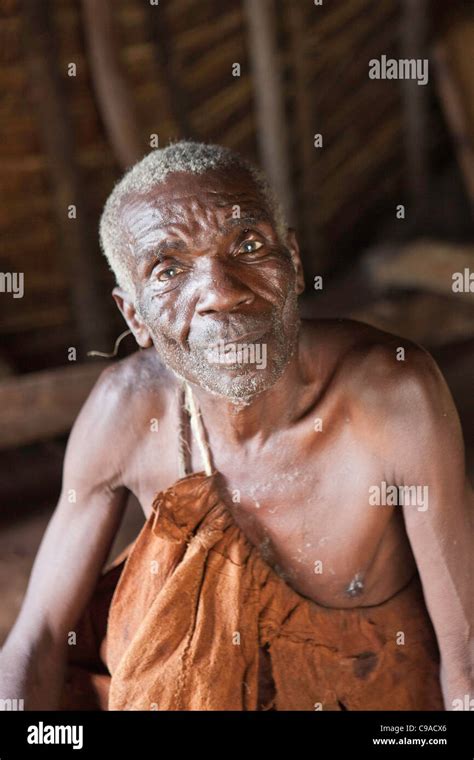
[0,166,474,709]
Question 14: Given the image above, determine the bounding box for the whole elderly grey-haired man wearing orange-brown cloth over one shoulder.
[0,142,473,710]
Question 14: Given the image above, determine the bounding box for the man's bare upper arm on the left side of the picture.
[12,369,131,648]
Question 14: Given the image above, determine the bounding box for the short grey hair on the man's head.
[99,140,287,295]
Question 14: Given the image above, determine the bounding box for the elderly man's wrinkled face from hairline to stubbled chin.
[118,169,299,402]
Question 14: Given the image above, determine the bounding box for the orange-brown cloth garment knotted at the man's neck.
[62,386,443,711]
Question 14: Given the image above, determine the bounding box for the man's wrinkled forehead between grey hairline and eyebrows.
[120,167,274,248]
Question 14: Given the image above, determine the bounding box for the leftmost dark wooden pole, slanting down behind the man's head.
[22,0,109,350]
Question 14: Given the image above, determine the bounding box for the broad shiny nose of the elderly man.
[196,259,255,316]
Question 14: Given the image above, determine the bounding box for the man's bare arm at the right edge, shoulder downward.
[386,352,474,707]
